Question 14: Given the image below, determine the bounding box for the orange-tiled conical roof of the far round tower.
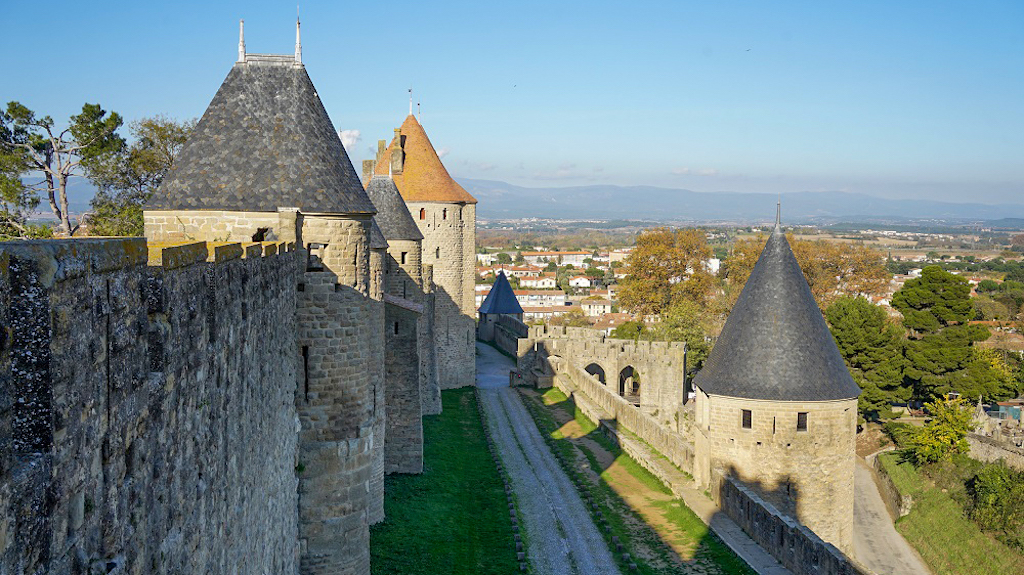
[374,114,476,204]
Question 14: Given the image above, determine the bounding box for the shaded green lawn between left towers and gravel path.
[370,388,519,575]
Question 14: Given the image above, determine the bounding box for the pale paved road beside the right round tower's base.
[853,457,931,575]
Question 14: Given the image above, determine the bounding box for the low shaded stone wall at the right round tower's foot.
[712,476,873,575]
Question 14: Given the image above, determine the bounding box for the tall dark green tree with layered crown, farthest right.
[892,266,1009,399]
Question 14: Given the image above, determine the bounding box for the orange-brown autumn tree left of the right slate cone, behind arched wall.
[618,227,714,315]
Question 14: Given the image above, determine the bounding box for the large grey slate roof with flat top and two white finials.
[145,54,374,214]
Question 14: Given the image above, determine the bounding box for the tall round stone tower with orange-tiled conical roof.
[374,114,476,389]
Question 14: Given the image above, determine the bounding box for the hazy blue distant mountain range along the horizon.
[459,179,1024,224]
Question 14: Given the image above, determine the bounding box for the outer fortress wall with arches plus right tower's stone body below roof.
[520,323,870,575]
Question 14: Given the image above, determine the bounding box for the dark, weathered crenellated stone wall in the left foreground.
[0,239,298,574]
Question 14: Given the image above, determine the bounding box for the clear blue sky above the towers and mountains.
[0,0,1024,203]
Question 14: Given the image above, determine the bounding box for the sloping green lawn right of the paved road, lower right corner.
[879,452,1024,575]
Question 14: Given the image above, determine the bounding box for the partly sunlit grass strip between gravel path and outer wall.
[523,388,754,575]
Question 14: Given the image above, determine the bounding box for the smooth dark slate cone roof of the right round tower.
[693,216,860,401]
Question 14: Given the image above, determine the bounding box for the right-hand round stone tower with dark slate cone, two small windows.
[693,209,860,552]
